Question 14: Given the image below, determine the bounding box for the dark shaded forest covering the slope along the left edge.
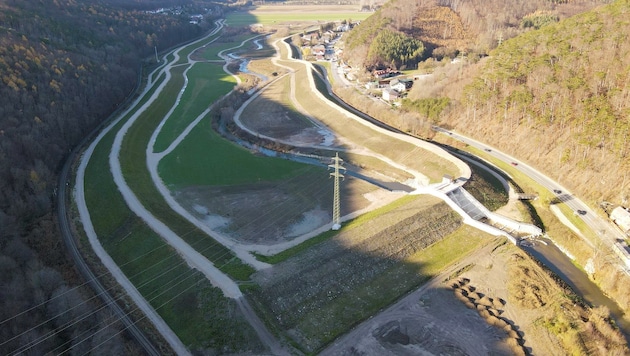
[0,0,220,354]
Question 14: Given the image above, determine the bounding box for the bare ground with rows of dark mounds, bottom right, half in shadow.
[322,242,628,356]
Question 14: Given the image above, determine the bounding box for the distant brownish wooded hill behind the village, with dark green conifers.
[344,0,603,69]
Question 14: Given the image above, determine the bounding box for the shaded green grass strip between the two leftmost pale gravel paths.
[85,36,261,351]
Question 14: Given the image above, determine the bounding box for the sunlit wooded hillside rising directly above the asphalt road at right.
[443,0,630,205]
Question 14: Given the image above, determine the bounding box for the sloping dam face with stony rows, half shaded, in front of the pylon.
[248,196,494,352]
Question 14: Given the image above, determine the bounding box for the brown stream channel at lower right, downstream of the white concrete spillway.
[521,238,630,343]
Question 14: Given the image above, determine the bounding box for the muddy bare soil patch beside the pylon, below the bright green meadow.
[175,171,381,245]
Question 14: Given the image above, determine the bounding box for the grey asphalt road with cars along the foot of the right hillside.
[434,127,630,273]
